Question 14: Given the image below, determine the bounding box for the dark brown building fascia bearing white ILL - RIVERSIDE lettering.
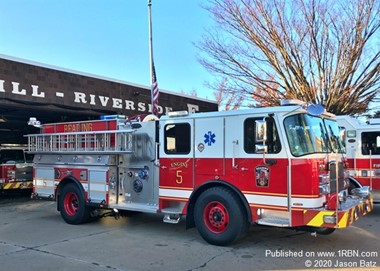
[0,56,218,116]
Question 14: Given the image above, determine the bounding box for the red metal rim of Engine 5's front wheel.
[203,201,230,233]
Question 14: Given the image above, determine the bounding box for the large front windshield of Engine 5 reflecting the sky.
[284,114,343,156]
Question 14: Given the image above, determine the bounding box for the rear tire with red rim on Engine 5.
[58,183,91,225]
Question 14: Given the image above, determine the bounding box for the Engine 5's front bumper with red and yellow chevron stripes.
[303,197,373,228]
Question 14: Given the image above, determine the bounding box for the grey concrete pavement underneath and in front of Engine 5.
[0,194,380,271]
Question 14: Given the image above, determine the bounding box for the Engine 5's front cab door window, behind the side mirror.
[244,118,281,153]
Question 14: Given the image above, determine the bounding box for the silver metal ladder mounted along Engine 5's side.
[26,129,135,154]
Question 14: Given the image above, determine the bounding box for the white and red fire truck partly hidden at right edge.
[336,116,380,203]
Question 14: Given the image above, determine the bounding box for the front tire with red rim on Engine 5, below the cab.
[194,187,249,246]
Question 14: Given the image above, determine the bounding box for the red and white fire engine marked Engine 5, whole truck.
[27,102,373,245]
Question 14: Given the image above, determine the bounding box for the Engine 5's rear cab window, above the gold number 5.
[164,123,191,154]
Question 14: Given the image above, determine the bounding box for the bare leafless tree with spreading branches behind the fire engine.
[197,0,380,114]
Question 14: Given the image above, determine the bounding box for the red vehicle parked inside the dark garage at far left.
[0,145,33,191]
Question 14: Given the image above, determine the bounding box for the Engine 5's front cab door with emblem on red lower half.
[226,115,288,208]
